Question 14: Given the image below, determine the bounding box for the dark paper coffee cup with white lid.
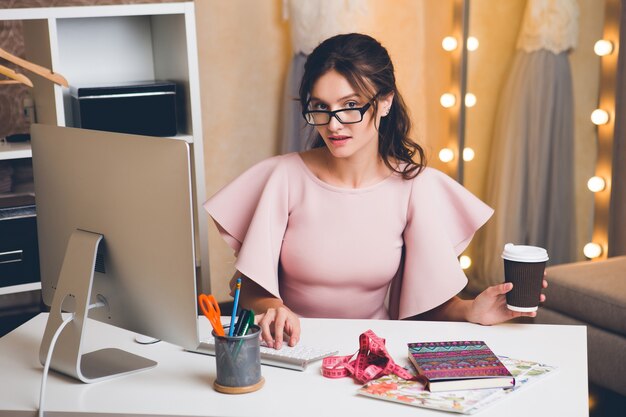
[502,243,548,312]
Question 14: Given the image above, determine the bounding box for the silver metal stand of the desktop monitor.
[39,229,157,383]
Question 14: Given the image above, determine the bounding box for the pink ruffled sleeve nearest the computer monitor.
[204,156,289,298]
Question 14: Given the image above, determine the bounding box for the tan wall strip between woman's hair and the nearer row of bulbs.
[365,0,455,171]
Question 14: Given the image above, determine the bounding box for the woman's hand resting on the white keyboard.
[257,304,300,349]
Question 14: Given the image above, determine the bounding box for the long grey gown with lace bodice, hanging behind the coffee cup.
[470,0,578,291]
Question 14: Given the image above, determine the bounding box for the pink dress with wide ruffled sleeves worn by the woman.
[204,153,493,319]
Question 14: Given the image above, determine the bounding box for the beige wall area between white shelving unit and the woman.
[196,0,290,300]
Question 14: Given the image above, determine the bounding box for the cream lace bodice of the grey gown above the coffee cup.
[517,0,579,54]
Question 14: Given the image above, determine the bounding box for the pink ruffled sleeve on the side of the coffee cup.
[389,169,493,319]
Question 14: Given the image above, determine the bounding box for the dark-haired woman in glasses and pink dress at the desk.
[205,34,547,349]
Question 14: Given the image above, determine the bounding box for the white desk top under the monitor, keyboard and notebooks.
[0,314,588,417]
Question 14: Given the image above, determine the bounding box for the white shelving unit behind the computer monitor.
[0,2,210,292]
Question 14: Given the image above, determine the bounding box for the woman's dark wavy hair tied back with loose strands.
[299,33,426,179]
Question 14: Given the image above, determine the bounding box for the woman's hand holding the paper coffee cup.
[467,279,548,325]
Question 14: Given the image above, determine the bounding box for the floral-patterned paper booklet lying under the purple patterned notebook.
[357,356,556,414]
